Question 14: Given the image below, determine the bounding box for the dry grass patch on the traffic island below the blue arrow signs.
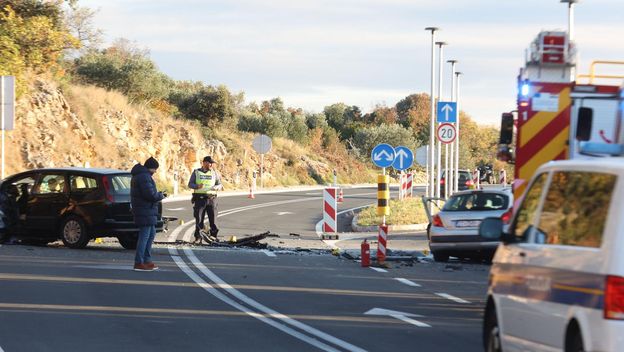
[357,197,429,226]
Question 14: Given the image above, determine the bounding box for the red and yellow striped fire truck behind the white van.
[497,31,624,199]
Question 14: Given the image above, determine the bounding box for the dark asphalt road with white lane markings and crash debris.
[0,189,489,352]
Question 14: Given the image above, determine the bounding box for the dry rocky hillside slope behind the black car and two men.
[6,80,372,189]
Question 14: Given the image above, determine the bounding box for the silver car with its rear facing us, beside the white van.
[427,190,513,262]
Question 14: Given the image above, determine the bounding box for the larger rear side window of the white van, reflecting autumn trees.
[535,171,617,247]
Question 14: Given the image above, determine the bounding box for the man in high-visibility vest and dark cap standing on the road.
[188,156,223,242]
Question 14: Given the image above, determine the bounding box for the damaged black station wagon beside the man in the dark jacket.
[0,168,163,249]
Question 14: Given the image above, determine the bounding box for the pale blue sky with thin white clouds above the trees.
[80,0,624,125]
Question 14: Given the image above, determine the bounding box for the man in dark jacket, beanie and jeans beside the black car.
[130,157,166,271]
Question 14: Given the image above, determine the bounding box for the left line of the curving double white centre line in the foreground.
[170,252,339,352]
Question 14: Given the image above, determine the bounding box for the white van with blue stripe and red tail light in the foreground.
[479,158,624,352]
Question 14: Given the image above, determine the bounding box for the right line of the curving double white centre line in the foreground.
[184,248,365,352]
